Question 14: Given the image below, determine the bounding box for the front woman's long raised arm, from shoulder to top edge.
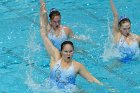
[40,0,60,60]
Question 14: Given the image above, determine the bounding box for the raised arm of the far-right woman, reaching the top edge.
[110,0,119,39]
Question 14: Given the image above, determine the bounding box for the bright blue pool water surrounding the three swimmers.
[0,0,140,93]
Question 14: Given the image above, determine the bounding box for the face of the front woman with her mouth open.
[61,44,73,61]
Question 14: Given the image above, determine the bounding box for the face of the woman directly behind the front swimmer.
[51,16,61,29]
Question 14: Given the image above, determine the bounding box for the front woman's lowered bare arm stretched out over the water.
[79,64,103,85]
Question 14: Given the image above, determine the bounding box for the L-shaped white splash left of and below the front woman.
[24,24,81,93]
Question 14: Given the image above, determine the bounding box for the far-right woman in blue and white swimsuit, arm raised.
[110,0,140,62]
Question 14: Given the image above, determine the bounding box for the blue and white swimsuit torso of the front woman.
[50,59,76,88]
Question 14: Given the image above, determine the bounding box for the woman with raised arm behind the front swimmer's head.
[40,0,73,50]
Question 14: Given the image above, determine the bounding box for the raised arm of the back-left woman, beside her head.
[40,0,50,34]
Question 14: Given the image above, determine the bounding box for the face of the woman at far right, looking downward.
[120,22,131,37]
